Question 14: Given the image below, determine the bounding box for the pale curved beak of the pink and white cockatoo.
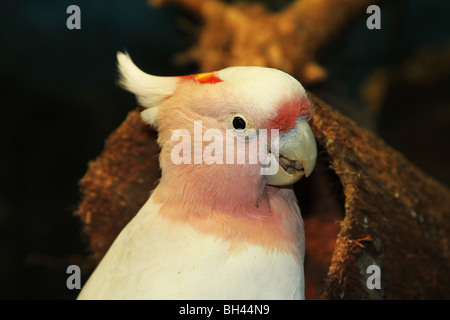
[265,119,317,186]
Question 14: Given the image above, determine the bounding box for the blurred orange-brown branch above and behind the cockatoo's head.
[150,0,378,85]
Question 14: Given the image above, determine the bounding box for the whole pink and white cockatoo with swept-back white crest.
[78,52,317,299]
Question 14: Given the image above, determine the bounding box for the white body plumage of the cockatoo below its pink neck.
[78,198,304,300]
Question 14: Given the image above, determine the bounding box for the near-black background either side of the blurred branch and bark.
[0,0,450,299]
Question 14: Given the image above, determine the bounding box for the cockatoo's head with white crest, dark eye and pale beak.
[117,53,317,185]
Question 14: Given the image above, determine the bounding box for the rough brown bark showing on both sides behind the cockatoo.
[77,94,450,299]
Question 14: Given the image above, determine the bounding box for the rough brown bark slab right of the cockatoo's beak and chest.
[312,98,450,299]
